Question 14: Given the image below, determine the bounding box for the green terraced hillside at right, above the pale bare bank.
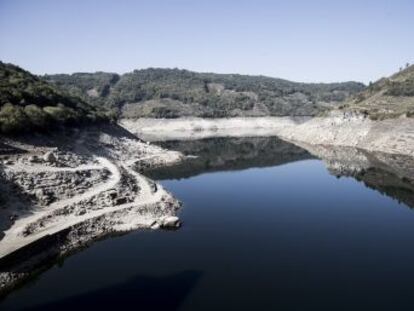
[340,66,414,120]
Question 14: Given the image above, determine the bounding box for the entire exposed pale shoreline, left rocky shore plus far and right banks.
[0,114,414,296]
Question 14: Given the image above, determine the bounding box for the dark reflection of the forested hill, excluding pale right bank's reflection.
[146,137,313,179]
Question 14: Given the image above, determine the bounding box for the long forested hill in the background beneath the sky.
[43,68,364,118]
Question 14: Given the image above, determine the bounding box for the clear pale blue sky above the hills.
[0,0,414,82]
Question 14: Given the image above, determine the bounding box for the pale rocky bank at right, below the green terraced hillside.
[278,112,414,156]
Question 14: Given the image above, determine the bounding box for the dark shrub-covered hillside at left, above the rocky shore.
[0,62,113,133]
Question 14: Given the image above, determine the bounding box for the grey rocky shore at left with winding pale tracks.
[0,125,183,294]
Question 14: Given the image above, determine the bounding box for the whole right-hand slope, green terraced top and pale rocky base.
[280,66,414,157]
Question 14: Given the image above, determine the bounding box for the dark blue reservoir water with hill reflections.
[0,138,414,310]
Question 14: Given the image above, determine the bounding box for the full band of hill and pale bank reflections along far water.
[150,137,414,208]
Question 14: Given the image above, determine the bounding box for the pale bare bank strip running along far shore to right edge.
[121,113,414,156]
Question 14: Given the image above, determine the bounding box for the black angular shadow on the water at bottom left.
[27,271,202,311]
